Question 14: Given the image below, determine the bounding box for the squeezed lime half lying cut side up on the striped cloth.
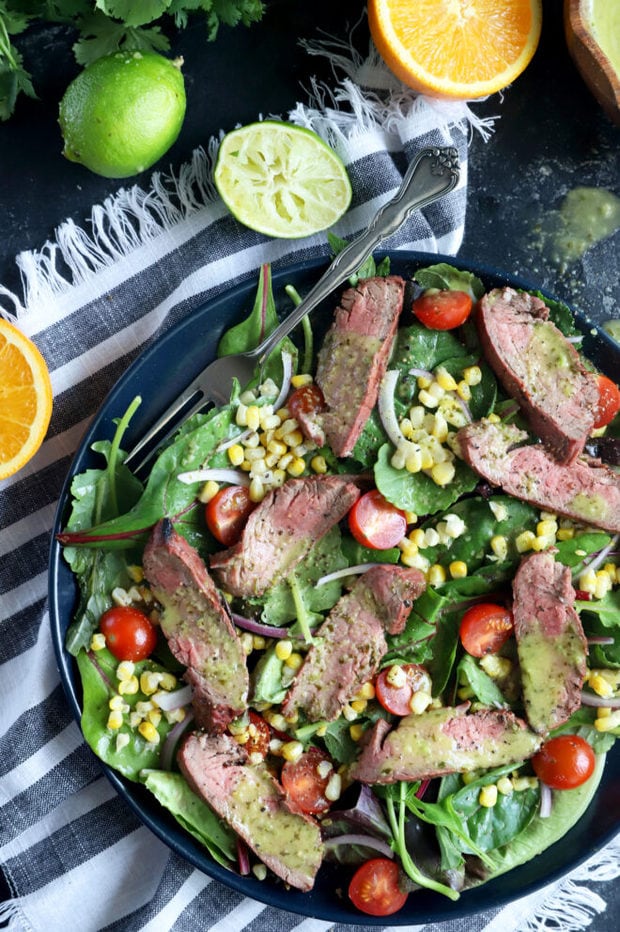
[214,120,352,239]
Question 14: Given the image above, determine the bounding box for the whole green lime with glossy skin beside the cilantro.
[58,51,186,178]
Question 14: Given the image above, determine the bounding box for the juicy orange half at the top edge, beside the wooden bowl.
[368,0,542,100]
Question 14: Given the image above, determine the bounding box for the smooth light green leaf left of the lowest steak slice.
[144,770,237,867]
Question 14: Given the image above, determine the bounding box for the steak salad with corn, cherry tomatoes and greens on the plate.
[58,253,620,916]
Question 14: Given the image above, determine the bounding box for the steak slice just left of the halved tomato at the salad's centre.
[210,476,360,597]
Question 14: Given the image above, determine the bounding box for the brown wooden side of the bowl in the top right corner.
[564,0,620,125]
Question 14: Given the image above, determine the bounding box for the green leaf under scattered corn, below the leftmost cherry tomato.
[77,649,172,781]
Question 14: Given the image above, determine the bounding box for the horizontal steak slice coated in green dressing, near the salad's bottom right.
[349,703,542,783]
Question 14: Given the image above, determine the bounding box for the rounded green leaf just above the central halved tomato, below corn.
[374,443,478,515]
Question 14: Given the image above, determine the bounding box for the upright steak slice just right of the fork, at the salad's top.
[316,275,405,456]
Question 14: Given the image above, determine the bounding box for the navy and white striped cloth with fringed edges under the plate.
[0,52,617,932]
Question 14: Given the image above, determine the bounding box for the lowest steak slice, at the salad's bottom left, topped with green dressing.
[177,734,323,890]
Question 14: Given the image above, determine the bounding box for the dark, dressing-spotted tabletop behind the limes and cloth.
[0,0,620,920]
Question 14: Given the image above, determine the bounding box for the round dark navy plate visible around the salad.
[49,252,620,926]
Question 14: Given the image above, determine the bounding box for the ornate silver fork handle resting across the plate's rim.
[253,146,459,364]
